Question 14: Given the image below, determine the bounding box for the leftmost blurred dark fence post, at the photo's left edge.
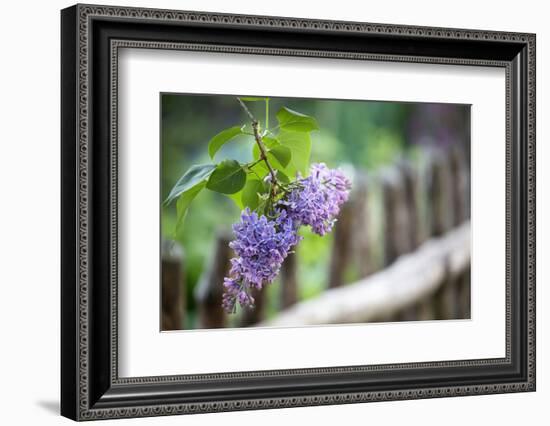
[161,240,185,331]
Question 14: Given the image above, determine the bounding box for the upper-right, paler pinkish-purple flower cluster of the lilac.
[279,163,351,236]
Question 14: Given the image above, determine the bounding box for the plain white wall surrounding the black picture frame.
[0,0,550,426]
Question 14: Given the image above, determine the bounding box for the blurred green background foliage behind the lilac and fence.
[161,94,469,327]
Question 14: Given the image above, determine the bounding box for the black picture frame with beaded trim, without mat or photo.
[61,5,536,420]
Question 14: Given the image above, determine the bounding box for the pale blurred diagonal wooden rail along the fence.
[262,222,470,326]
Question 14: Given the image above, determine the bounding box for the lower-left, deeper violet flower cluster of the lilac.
[222,208,301,312]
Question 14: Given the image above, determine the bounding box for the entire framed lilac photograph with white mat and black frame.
[61,5,535,420]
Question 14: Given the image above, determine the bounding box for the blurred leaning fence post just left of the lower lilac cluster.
[195,232,233,328]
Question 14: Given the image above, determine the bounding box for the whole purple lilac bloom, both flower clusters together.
[222,163,351,313]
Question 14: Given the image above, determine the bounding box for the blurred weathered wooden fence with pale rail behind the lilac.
[163,149,470,330]
